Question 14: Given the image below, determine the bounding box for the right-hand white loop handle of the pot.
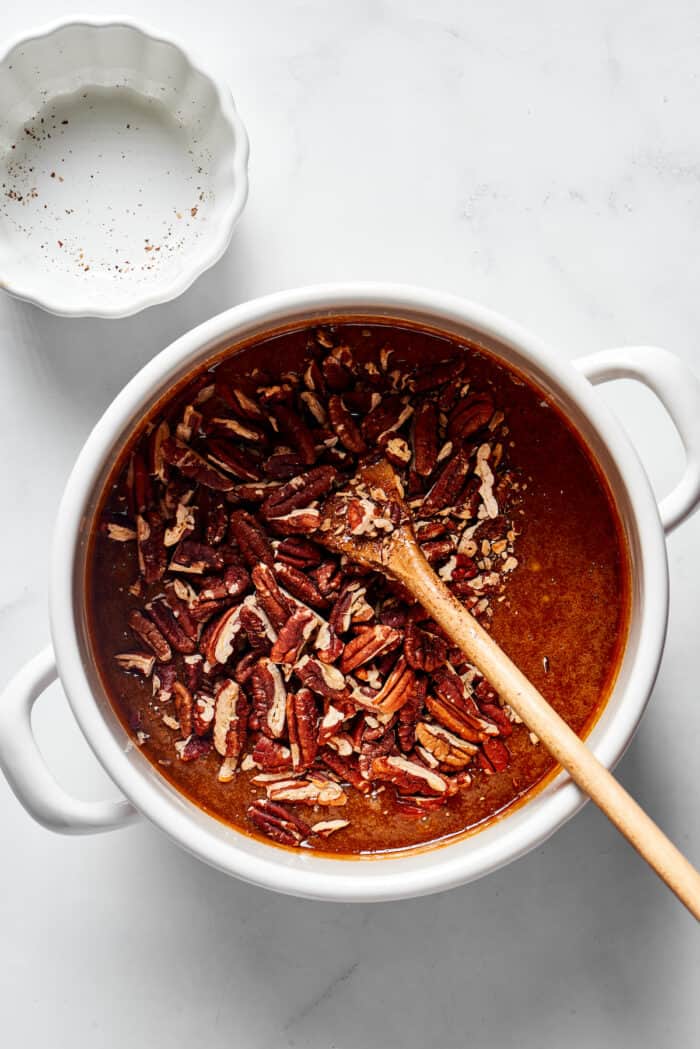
[574,346,700,534]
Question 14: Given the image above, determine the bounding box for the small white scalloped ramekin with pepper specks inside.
[0,19,249,317]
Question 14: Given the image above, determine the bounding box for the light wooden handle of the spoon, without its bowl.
[391,543,700,921]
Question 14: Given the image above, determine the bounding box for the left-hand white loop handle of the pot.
[0,645,139,834]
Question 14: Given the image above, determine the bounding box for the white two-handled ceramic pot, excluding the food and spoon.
[0,283,700,900]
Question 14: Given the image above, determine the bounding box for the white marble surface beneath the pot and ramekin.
[0,0,700,1049]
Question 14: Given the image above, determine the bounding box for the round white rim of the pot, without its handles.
[49,282,669,901]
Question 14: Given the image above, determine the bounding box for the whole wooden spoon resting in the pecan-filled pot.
[317,458,700,920]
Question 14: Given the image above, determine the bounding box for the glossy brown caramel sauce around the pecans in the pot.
[86,318,630,857]
